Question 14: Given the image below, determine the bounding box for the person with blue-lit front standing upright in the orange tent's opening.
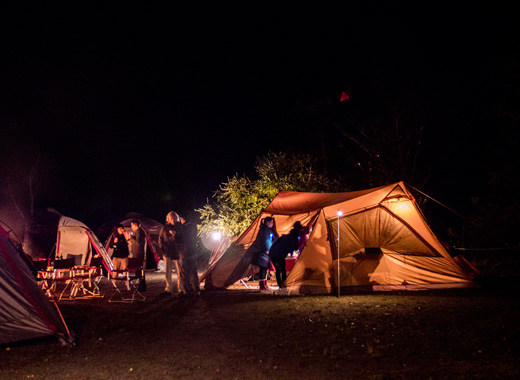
[251,216,278,290]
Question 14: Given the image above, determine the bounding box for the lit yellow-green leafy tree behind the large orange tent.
[196,152,345,237]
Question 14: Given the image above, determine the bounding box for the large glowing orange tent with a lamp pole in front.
[202,182,472,294]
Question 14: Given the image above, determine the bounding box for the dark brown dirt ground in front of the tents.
[0,273,520,380]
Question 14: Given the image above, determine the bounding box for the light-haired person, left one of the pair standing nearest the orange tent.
[159,211,183,294]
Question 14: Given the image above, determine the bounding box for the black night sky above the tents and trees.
[0,2,518,229]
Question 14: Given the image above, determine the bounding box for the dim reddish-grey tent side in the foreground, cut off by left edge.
[0,226,72,344]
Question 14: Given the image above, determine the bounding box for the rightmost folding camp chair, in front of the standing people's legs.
[108,258,146,302]
